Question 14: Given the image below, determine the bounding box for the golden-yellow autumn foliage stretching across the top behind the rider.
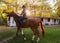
[0,0,60,17]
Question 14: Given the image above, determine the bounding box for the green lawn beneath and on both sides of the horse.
[0,26,60,43]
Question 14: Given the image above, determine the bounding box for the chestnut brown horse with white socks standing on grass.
[5,12,45,42]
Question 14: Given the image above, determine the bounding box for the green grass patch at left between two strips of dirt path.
[0,29,16,41]
